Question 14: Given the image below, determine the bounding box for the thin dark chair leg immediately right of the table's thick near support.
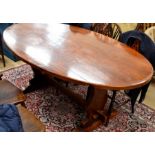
[105,90,116,126]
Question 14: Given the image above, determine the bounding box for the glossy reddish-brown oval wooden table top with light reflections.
[3,24,153,90]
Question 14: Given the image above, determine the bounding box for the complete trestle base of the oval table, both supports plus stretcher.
[26,68,107,131]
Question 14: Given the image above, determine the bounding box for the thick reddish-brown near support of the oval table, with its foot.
[78,86,107,131]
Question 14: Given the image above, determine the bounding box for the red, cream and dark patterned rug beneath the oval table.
[3,65,155,132]
